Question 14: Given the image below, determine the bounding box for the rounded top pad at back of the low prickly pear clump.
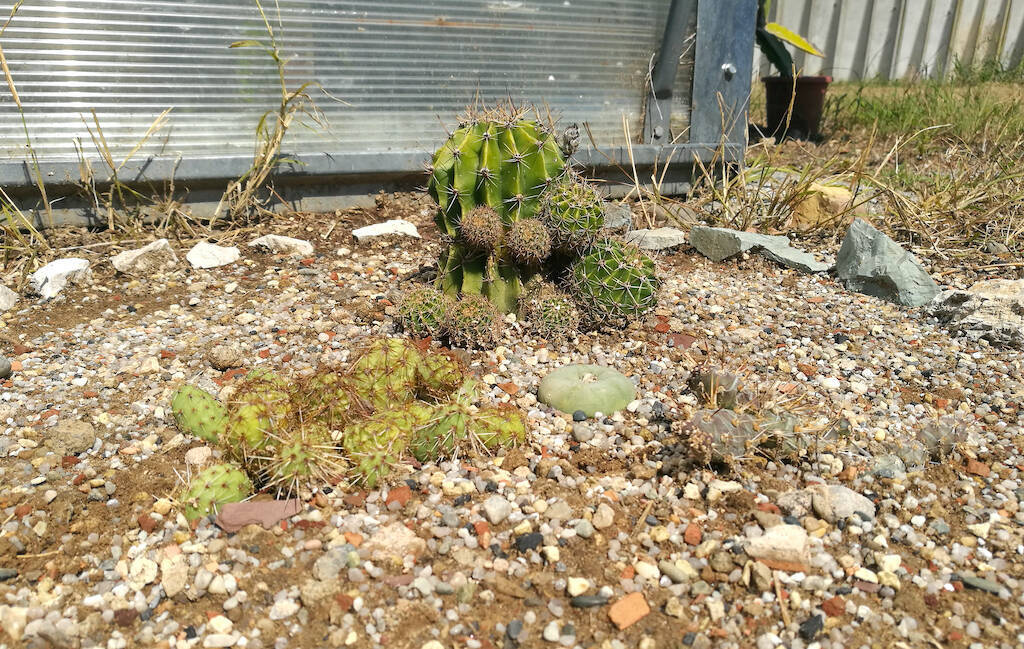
[347,338,423,409]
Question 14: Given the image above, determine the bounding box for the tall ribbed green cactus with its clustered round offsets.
[421,101,658,337]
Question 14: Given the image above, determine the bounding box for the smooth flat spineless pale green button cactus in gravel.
[537,365,636,417]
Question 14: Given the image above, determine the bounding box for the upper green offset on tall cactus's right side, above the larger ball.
[539,174,604,255]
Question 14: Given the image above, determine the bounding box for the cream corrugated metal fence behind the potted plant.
[755,0,1024,80]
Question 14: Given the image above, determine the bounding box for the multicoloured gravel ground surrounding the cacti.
[0,198,1024,649]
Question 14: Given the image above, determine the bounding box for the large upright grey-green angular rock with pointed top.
[836,219,939,306]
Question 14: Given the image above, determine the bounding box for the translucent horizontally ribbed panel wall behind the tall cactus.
[0,0,695,161]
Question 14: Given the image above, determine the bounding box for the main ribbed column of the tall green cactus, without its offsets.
[428,107,565,313]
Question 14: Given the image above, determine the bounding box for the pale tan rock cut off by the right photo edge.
[926,279,1024,349]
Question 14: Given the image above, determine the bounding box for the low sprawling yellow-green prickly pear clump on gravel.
[171,339,526,519]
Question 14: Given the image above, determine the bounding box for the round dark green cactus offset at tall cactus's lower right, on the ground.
[568,240,659,322]
